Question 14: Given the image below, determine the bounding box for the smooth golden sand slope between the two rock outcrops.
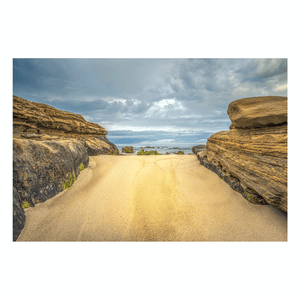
[17,155,287,241]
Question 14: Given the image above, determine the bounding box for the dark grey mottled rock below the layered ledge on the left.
[13,138,89,240]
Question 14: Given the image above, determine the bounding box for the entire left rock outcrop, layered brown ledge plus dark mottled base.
[13,96,119,240]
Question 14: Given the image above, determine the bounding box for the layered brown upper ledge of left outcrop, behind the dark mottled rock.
[13,96,119,156]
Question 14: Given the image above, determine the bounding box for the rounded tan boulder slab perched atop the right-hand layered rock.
[227,96,287,129]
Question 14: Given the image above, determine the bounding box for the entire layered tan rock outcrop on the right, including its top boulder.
[197,96,287,212]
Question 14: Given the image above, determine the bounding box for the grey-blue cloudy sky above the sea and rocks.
[13,59,287,147]
